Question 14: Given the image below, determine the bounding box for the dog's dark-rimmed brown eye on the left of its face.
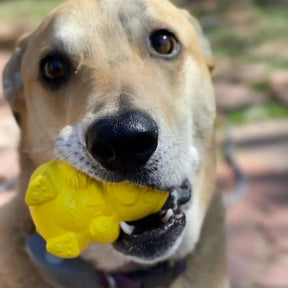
[40,55,71,87]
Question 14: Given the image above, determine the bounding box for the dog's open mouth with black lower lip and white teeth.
[113,181,191,262]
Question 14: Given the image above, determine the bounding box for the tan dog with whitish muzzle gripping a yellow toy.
[0,0,229,288]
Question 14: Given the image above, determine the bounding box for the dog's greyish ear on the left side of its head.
[2,34,29,113]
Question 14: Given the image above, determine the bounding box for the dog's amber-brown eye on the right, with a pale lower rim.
[150,29,179,57]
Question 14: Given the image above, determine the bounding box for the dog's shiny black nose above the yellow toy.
[86,111,158,172]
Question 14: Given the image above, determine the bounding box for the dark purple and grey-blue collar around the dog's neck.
[27,234,185,288]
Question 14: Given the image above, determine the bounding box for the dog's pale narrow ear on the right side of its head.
[182,9,215,72]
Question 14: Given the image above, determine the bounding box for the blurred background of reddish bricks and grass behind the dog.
[0,0,288,288]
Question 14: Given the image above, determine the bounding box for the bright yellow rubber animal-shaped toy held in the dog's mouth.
[25,162,168,258]
